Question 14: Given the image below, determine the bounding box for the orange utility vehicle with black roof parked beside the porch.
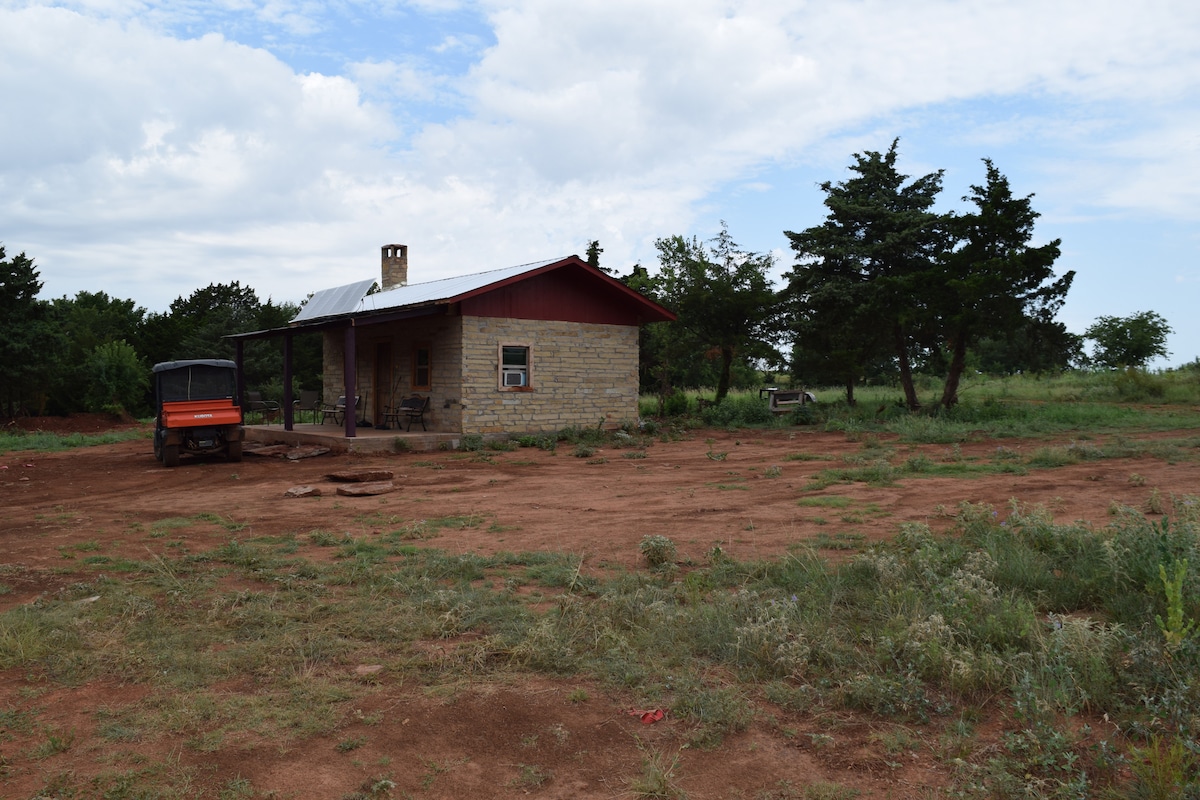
[154,359,245,467]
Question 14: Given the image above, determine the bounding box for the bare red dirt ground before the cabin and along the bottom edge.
[0,417,1200,800]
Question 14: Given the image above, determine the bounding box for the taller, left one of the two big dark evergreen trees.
[785,139,946,409]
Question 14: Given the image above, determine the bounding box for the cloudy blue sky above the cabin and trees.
[0,0,1200,366]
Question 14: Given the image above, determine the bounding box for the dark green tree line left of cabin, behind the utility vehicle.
[0,246,322,417]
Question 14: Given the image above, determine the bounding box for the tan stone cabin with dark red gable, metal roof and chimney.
[253,245,674,437]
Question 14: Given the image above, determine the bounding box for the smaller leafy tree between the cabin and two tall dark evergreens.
[652,224,780,402]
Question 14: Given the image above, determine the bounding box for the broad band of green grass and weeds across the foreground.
[7,504,1200,798]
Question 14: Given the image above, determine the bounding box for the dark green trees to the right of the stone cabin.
[624,140,1171,410]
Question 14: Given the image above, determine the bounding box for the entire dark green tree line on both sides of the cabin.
[0,140,1171,417]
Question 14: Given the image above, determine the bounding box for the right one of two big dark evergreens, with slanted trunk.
[923,158,1075,408]
